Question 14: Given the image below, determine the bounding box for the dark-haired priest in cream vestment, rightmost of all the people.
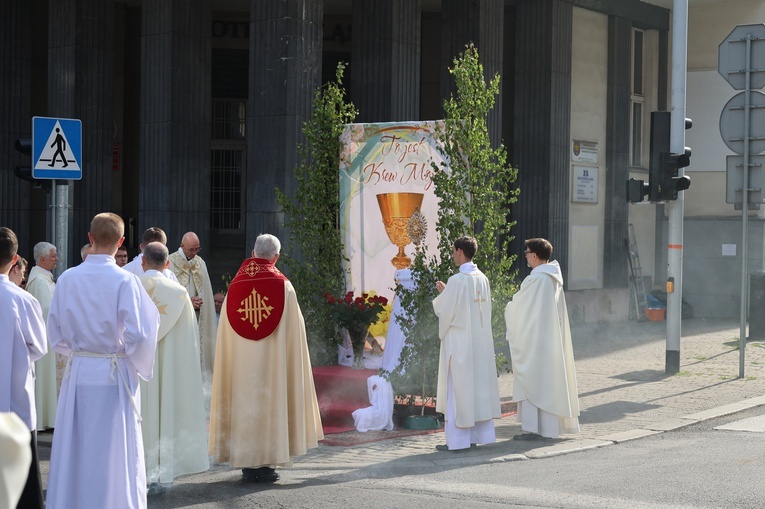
[505,238,579,440]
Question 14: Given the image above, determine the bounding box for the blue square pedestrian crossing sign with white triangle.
[32,117,82,180]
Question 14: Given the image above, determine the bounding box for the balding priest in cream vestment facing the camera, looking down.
[169,232,218,388]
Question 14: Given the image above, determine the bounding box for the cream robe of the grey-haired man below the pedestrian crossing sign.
[26,266,58,429]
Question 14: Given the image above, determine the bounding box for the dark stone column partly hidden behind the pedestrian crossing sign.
[47,0,114,266]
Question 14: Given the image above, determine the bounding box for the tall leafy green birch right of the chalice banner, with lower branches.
[383,44,518,410]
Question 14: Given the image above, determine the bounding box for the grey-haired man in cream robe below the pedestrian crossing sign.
[27,242,59,430]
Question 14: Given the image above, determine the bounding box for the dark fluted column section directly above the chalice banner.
[351,0,422,122]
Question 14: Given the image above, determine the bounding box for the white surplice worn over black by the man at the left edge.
[0,274,48,428]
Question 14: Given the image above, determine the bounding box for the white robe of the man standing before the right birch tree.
[433,262,502,430]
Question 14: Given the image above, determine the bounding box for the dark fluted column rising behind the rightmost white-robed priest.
[511,0,573,277]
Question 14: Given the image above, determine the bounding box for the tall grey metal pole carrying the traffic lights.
[665,0,688,375]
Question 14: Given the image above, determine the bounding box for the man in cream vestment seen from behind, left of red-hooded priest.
[141,242,209,488]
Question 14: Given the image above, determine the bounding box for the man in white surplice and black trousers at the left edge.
[0,227,48,509]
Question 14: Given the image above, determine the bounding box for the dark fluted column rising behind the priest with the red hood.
[245,0,323,249]
